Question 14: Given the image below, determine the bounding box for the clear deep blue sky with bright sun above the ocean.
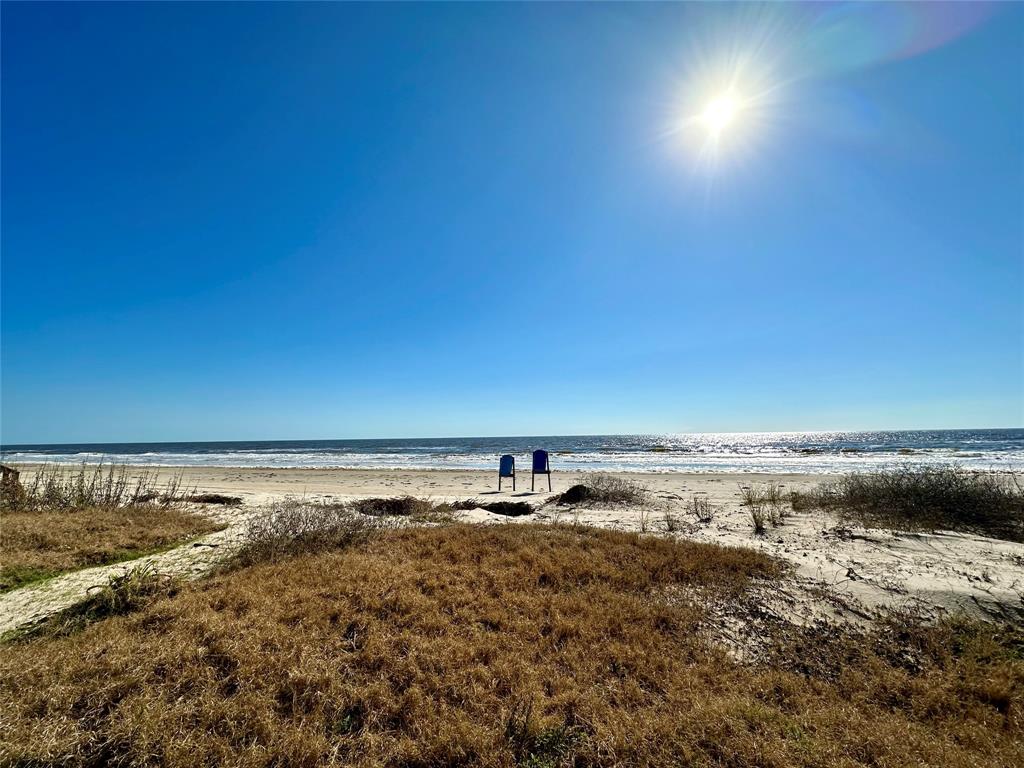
[0,3,1024,444]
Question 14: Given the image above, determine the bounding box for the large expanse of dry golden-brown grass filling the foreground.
[0,525,1024,768]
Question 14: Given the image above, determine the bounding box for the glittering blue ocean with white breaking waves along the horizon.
[0,429,1024,474]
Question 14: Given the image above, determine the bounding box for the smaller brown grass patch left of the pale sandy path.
[0,504,223,592]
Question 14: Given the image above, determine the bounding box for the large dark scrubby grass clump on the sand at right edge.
[793,466,1024,542]
